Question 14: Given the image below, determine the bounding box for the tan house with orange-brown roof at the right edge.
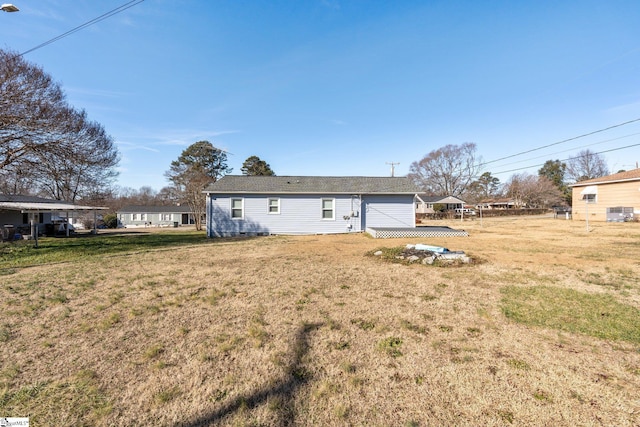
[571,169,640,221]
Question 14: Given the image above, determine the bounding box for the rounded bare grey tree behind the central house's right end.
[408,142,480,196]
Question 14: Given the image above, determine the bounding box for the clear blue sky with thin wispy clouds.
[0,0,640,190]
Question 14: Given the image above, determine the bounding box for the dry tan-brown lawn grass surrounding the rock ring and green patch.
[0,218,640,426]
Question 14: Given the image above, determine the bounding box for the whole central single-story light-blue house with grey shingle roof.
[204,175,420,237]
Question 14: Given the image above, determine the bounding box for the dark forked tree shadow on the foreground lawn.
[180,323,322,427]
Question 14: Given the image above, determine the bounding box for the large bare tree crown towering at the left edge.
[0,50,119,201]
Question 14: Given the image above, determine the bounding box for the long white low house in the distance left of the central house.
[117,205,195,228]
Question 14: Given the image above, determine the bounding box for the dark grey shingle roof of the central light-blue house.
[204,175,420,194]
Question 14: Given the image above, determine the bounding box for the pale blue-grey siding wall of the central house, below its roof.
[207,194,415,237]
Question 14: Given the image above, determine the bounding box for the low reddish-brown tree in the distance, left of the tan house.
[504,172,563,208]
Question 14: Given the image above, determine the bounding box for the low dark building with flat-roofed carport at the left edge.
[0,194,107,240]
